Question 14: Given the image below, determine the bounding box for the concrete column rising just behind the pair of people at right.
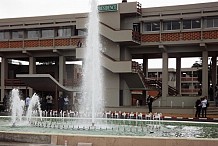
[202,51,208,96]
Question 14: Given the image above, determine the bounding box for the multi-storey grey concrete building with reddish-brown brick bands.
[0,2,218,106]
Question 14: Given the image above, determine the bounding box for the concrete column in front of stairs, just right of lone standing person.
[161,52,168,106]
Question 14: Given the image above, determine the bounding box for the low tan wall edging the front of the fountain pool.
[0,132,218,146]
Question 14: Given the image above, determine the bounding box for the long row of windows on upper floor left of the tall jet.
[0,26,86,40]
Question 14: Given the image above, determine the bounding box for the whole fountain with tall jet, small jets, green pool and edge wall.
[0,0,218,146]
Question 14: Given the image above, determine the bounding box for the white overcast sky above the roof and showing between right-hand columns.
[0,0,216,68]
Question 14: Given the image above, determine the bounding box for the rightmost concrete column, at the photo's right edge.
[212,56,217,97]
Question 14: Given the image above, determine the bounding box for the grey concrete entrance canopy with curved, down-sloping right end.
[16,74,77,92]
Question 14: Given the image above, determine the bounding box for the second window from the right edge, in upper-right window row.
[183,19,201,29]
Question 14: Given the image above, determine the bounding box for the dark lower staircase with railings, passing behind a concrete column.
[132,61,178,97]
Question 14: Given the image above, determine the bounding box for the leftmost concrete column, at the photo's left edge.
[0,57,7,101]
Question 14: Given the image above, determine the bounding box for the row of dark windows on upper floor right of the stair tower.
[144,17,218,31]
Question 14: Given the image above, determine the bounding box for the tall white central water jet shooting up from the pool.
[79,0,104,124]
